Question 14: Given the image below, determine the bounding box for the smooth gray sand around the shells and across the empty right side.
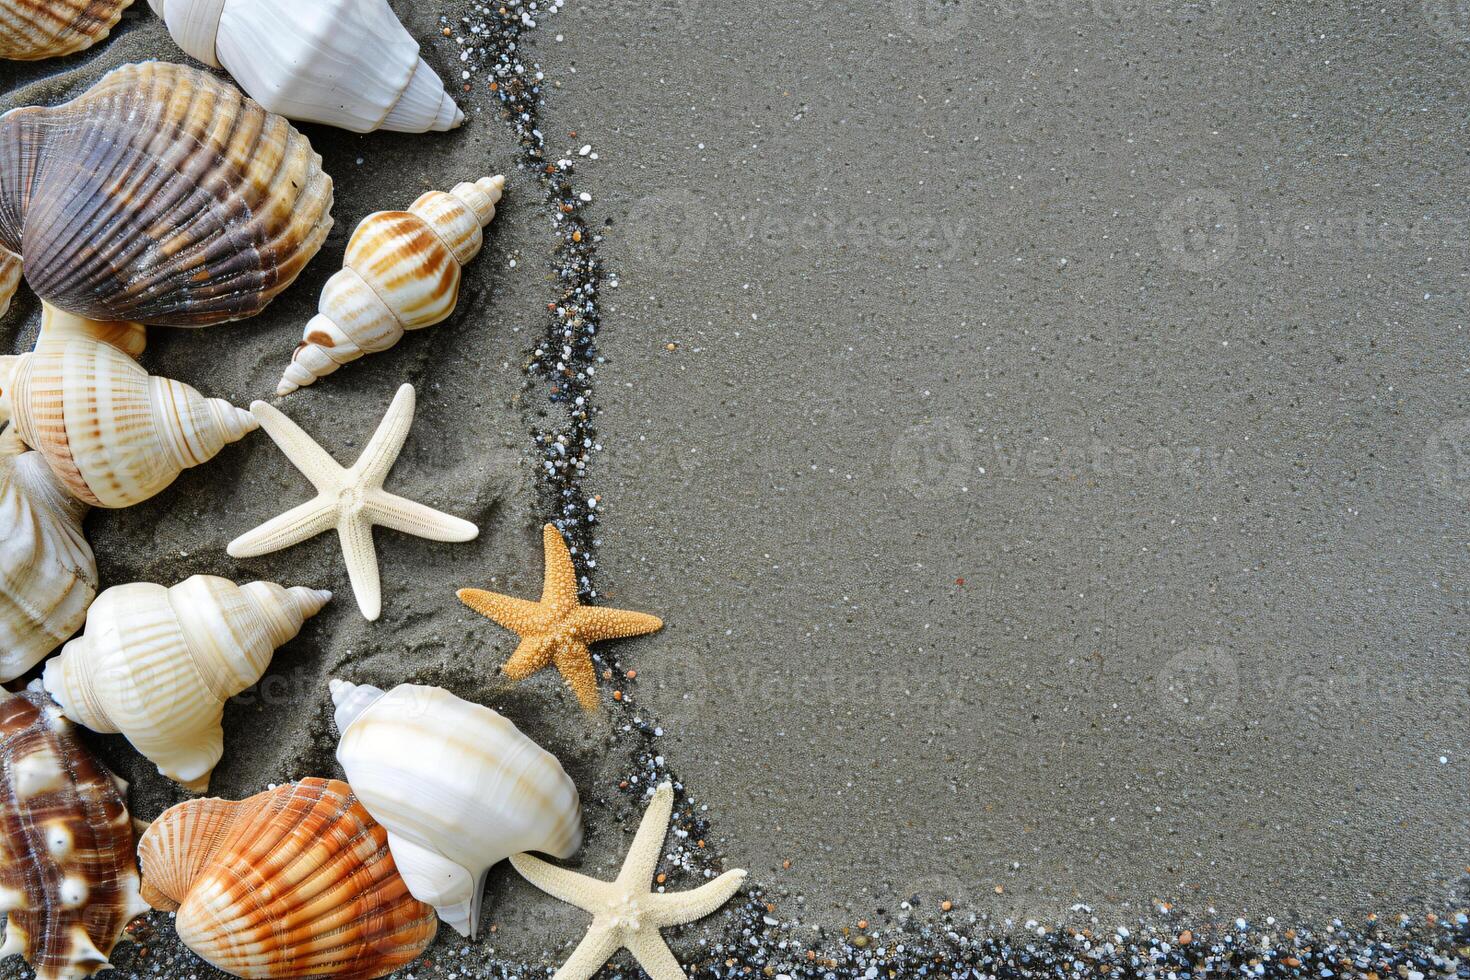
[0,0,1470,976]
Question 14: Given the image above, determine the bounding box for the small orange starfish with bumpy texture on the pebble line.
[459,525,663,711]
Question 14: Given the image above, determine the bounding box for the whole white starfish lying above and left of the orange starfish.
[226,385,479,620]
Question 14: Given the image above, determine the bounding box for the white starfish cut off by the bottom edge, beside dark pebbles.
[510,783,745,980]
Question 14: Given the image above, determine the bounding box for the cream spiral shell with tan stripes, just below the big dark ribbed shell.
[0,313,257,507]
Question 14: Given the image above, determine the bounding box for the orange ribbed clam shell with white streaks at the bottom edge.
[138,779,438,980]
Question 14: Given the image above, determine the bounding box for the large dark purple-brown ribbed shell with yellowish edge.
[0,61,332,326]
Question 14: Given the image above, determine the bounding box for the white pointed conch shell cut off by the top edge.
[148,0,465,132]
